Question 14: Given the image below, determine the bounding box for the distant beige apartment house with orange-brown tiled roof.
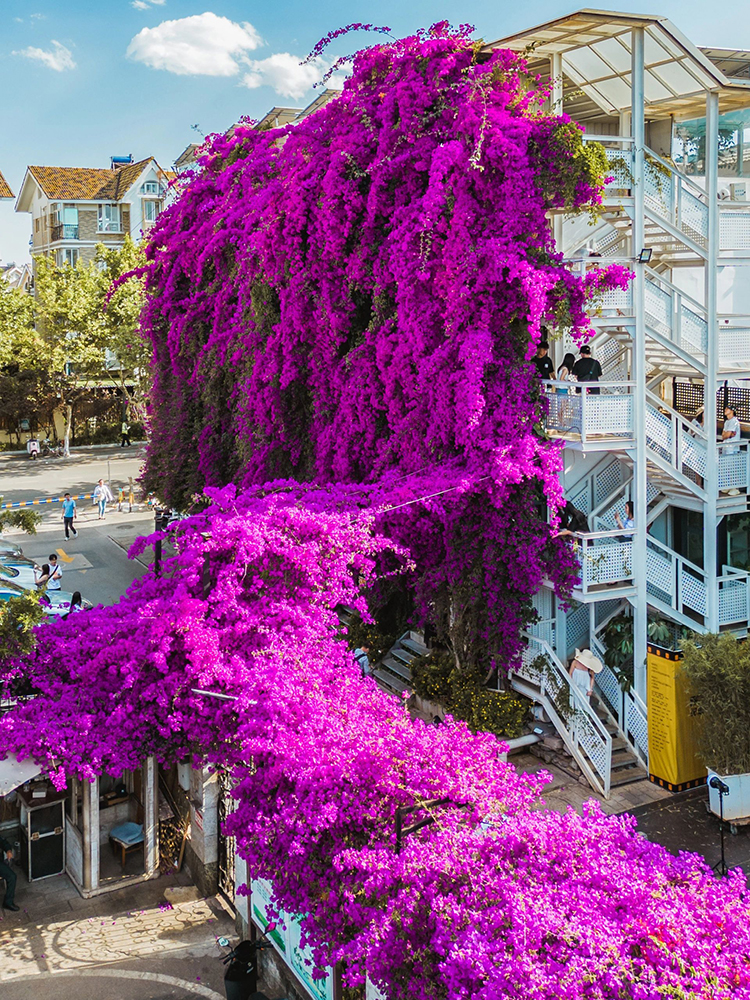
[16,156,174,265]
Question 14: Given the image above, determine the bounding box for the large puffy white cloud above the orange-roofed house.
[127,11,262,76]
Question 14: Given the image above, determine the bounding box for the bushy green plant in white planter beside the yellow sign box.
[683,632,750,824]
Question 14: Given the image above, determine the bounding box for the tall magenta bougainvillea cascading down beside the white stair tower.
[144,25,628,667]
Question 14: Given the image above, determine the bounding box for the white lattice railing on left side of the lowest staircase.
[511,633,612,798]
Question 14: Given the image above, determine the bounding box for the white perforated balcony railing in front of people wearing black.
[543,381,635,444]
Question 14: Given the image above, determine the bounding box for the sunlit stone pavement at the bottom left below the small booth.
[0,875,247,1000]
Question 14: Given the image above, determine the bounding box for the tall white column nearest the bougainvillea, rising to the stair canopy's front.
[630,28,648,702]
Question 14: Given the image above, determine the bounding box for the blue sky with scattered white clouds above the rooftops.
[0,0,750,262]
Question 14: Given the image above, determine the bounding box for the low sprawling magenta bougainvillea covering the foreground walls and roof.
[0,483,750,1000]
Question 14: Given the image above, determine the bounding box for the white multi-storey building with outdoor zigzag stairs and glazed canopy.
[487,10,750,796]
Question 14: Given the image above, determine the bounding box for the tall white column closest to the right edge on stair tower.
[703,92,719,632]
